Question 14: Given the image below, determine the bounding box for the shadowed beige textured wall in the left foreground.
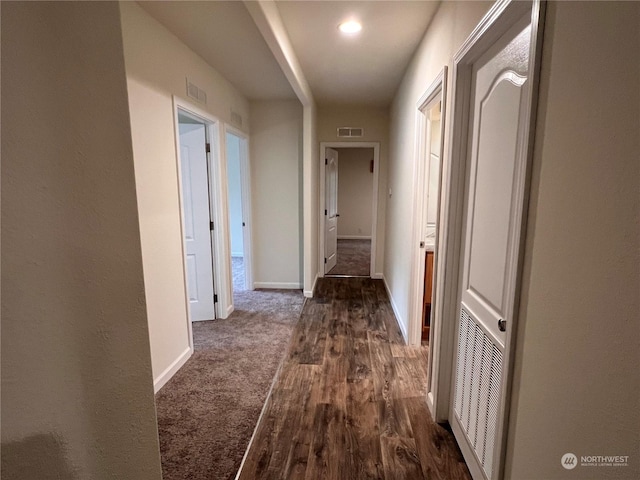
[1,2,161,480]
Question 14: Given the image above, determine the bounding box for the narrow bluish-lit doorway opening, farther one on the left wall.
[225,127,253,292]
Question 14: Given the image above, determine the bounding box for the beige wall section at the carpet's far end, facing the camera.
[250,100,303,288]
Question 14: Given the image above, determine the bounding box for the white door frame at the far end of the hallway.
[318,142,382,278]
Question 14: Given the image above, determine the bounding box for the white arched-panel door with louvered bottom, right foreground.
[451,14,531,479]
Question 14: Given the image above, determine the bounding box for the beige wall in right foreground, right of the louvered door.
[506,2,640,480]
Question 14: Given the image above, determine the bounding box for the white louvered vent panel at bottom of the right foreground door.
[454,308,502,478]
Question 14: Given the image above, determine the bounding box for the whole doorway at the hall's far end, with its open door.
[319,142,379,277]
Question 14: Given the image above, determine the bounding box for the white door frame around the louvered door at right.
[434,0,544,479]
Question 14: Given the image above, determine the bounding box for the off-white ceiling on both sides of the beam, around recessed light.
[139,0,439,106]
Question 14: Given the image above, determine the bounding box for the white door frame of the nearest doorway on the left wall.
[173,95,233,350]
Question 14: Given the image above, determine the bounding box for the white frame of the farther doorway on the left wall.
[223,124,254,290]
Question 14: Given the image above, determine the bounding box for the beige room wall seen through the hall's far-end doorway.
[336,148,373,238]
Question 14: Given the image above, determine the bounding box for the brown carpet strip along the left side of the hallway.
[156,290,303,480]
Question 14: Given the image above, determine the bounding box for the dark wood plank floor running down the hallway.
[238,278,471,480]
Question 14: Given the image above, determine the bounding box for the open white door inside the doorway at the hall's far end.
[324,148,339,273]
